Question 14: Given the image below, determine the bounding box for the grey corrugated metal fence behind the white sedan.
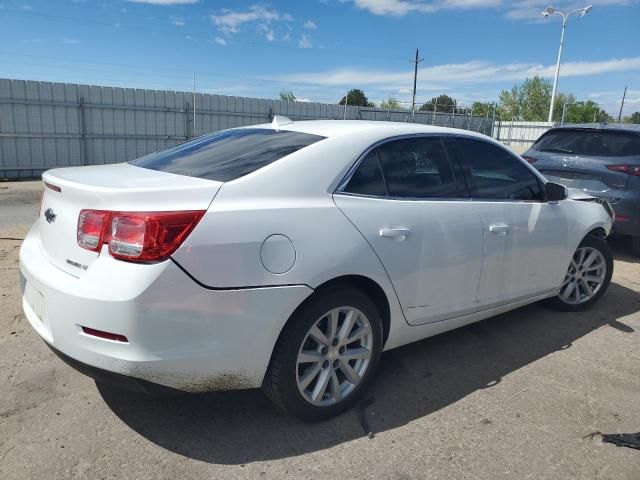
[0,79,493,178]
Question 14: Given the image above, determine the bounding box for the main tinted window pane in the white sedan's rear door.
[377,137,457,198]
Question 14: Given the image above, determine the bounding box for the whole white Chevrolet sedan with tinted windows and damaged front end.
[20,117,613,420]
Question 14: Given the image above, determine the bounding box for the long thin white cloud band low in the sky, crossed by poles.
[273,57,640,89]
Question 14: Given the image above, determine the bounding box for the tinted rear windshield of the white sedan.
[129,128,325,182]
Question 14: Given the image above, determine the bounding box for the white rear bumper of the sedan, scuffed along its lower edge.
[20,225,312,392]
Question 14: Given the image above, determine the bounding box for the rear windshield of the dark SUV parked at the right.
[532,130,640,157]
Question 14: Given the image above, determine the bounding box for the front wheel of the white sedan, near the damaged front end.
[545,235,613,312]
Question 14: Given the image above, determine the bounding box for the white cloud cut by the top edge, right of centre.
[345,0,637,20]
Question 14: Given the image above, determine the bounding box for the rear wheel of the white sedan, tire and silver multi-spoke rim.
[263,286,383,421]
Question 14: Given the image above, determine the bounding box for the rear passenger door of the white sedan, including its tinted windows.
[334,136,483,325]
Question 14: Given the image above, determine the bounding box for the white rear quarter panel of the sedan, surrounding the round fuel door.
[173,132,408,346]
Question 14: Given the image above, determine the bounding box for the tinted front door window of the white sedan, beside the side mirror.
[455,139,544,200]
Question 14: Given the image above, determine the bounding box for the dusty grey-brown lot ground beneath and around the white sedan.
[0,183,640,480]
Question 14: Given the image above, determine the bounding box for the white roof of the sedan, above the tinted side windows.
[246,120,487,138]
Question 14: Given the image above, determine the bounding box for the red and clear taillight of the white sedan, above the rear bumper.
[78,210,204,262]
